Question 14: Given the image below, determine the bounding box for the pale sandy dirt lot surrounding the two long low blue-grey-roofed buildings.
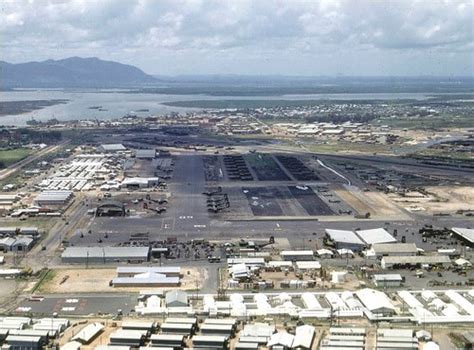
[39,267,207,293]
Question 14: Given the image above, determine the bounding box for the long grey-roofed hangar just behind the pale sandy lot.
[61,247,150,264]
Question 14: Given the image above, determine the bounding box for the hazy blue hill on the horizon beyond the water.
[0,57,158,89]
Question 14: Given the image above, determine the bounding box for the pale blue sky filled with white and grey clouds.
[0,0,474,76]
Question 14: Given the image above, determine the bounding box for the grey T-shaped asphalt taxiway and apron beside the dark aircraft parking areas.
[75,153,473,247]
